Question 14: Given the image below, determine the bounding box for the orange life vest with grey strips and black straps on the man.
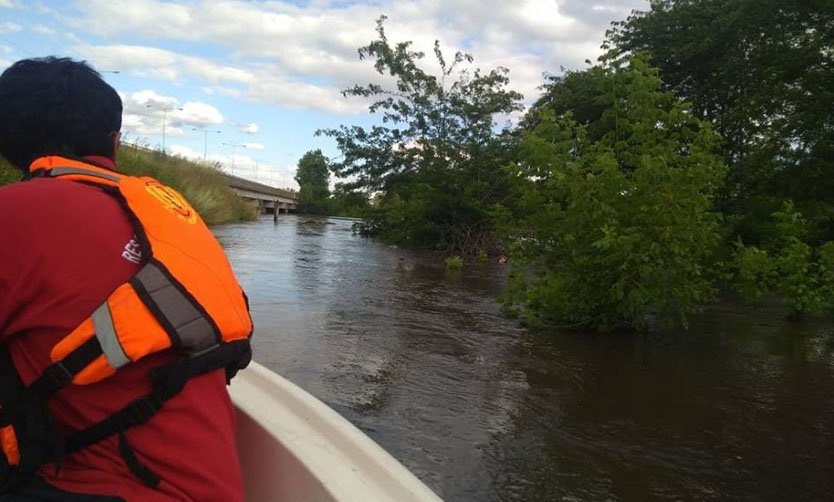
[0,156,252,485]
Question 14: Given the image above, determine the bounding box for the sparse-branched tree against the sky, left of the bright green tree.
[319,16,521,254]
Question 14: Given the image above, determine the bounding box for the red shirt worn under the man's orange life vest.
[0,157,243,501]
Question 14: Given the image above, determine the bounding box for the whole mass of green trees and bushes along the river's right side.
[319,0,834,330]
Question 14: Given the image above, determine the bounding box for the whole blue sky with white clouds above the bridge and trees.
[0,0,648,188]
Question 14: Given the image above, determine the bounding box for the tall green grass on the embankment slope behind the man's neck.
[0,144,257,225]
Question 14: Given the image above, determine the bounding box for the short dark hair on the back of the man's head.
[0,56,122,171]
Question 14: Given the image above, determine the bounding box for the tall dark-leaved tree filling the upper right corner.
[607,0,834,245]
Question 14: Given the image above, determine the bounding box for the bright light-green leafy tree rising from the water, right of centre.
[502,58,725,330]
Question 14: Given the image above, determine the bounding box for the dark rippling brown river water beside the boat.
[215,215,834,501]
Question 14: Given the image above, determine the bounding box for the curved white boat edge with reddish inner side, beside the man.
[229,362,440,502]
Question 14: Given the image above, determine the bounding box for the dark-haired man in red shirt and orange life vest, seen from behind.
[0,57,251,501]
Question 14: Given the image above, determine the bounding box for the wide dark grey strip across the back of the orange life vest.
[135,263,217,355]
